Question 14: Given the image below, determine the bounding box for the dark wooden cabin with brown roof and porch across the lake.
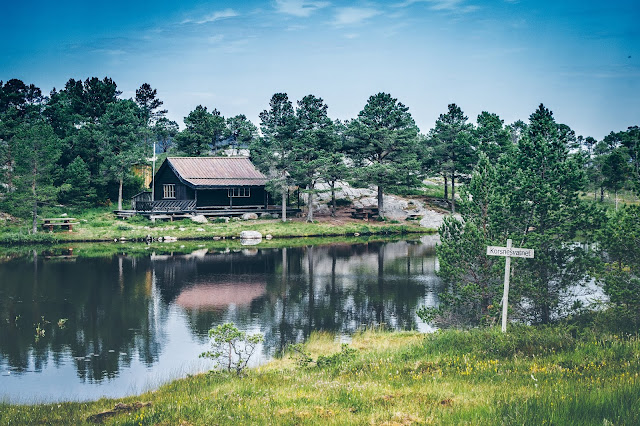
[134,157,268,214]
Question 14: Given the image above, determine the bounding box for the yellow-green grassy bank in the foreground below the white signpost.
[0,326,640,425]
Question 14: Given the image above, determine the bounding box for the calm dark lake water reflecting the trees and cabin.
[0,237,437,402]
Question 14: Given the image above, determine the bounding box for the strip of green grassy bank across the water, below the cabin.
[0,209,435,245]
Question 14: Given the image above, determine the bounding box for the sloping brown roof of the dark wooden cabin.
[167,157,267,187]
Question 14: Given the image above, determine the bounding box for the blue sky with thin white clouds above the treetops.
[0,0,640,139]
